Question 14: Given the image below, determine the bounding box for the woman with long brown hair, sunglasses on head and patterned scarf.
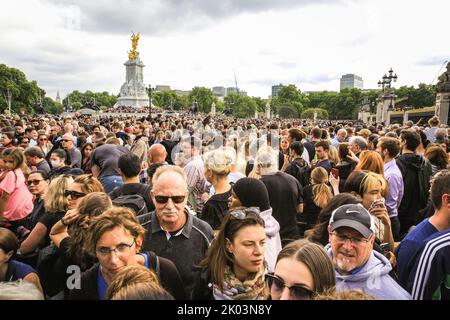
[192,207,268,300]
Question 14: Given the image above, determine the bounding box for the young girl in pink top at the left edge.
[0,148,33,230]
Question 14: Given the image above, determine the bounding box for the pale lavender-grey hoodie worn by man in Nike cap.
[325,244,412,300]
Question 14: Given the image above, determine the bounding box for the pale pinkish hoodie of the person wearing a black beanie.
[259,208,281,272]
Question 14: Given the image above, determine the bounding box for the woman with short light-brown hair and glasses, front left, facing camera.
[69,207,186,300]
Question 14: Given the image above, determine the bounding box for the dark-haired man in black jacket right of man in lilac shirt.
[396,129,432,235]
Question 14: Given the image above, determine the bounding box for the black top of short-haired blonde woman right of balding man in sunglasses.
[199,189,231,230]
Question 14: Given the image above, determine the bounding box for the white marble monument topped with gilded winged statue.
[114,33,150,108]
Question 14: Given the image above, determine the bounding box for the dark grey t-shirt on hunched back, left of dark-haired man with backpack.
[91,144,129,177]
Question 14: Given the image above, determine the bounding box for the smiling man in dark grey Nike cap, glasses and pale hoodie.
[326,204,411,300]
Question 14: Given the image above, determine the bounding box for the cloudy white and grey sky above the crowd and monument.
[0,0,450,98]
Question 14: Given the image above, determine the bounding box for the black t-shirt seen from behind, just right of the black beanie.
[261,172,303,240]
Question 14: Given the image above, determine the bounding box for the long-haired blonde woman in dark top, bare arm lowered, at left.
[19,176,73,254]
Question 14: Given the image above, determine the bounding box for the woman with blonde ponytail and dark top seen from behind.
[300,167,333,229]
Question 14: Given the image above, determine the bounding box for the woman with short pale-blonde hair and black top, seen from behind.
[199,149,233,230]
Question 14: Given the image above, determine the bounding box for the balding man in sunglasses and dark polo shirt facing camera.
[142,165,214,297]
